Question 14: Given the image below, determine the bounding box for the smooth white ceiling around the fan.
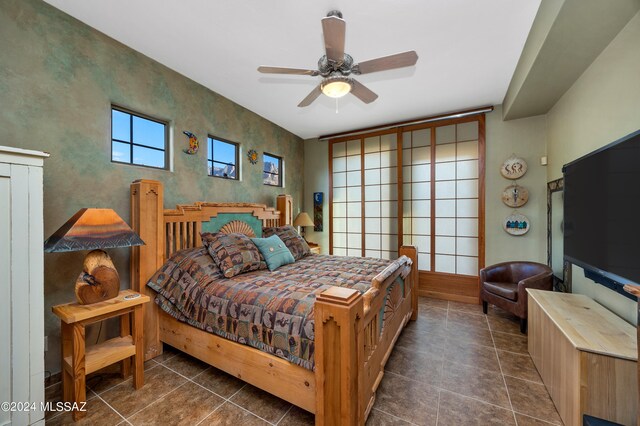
[46,0,540,138]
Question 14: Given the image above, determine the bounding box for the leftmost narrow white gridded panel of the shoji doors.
[330,139,362,256]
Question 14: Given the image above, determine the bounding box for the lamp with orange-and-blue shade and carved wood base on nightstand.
[44,209,144,305]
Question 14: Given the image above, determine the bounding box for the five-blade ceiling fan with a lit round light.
[258,10,418,107]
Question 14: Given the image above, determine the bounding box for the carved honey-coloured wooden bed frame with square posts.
[131,180,418,425]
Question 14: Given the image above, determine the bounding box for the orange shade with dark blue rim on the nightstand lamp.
[44,209,144,253]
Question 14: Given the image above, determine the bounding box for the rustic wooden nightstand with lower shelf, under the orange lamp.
[52,290,150,421]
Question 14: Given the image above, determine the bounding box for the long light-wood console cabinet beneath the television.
[527,289,638,425]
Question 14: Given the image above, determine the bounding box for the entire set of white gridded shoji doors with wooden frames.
[329,115,485,302]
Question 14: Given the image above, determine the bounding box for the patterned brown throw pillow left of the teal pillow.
[200,232,267,278]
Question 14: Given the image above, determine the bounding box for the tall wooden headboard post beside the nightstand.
[131,179,165,361]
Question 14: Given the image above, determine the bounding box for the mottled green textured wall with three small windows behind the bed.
[0,0,303,372]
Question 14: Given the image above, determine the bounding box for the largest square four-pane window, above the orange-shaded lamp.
[111,106,169,169]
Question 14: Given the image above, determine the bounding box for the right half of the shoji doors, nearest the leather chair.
[402,116,484,303]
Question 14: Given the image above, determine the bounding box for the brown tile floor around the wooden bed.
[46,298,562,426]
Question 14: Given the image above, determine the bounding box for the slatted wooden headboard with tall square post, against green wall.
[131,179,292,359]
